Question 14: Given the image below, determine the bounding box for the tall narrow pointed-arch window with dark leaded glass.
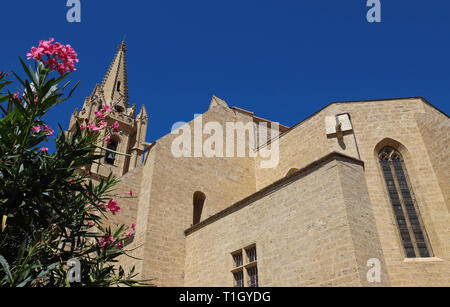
[378,147,432,258]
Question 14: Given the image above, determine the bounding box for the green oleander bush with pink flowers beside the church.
[0,39,145,287]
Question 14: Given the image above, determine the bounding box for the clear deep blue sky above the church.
[0,0,450,147]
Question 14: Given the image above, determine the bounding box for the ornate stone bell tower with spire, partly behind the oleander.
[69,42,148,179]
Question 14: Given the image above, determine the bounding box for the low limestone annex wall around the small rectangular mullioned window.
[184,153,389,286]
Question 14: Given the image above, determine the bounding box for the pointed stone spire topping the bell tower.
[101,41,128,112]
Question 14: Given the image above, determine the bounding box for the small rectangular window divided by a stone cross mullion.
[231,243,260,287]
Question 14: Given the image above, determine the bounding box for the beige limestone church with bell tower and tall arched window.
[69,43,450,287]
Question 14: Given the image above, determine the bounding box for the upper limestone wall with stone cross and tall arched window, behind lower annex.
[250,98,450,285]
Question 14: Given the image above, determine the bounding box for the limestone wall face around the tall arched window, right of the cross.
[326,98,450,286]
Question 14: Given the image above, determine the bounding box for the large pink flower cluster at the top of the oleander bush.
[27,38,79,75]
